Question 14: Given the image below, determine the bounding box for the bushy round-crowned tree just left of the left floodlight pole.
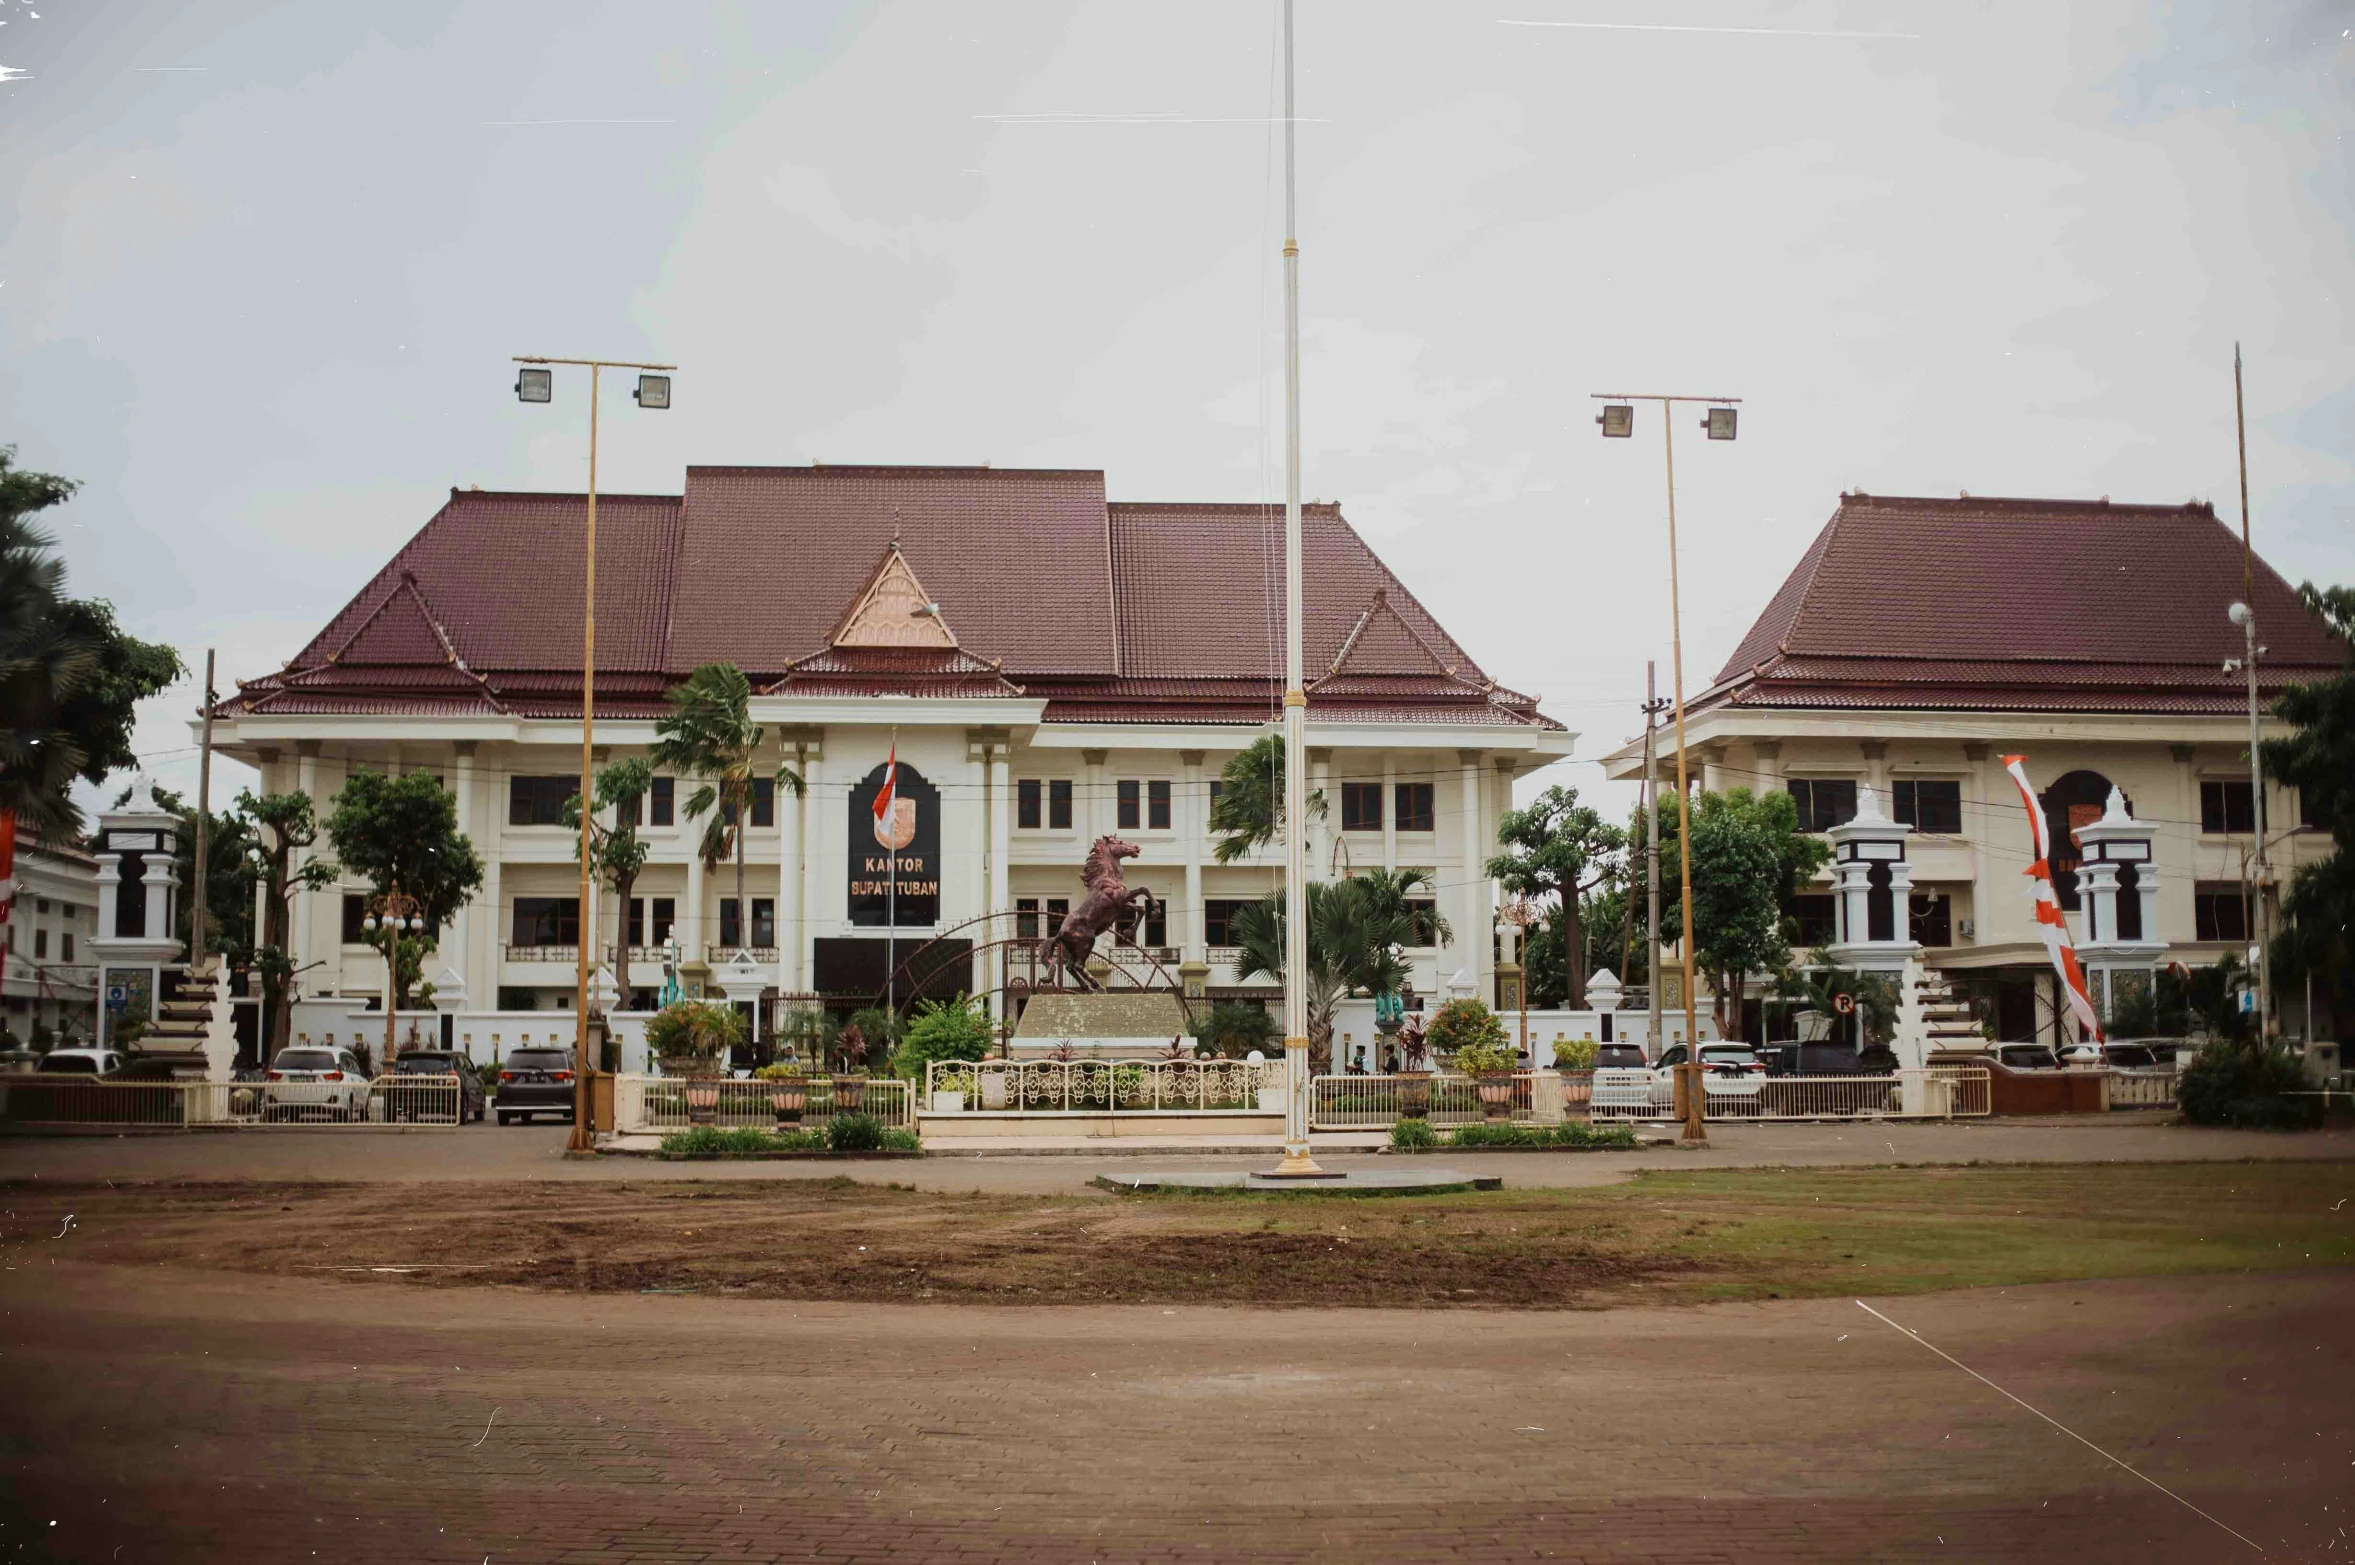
[327,772,483,1010]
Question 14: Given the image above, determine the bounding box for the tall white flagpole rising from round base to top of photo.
[1274,0,1324,1179]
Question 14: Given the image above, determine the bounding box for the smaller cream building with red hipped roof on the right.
[1604,494,2348,1040]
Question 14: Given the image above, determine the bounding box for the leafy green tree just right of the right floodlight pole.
[1658,788,1832,1038]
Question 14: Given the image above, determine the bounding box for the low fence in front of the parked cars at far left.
[0,1075,466,1130]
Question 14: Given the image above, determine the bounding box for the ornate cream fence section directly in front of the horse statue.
[923,1059,1283,1113]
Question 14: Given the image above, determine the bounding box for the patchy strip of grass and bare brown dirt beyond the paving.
[0,1163,2355,1308]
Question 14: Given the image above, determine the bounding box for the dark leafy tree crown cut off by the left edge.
[0,447,184,840]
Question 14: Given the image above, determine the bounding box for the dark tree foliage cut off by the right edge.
[2266,581,2355,1031]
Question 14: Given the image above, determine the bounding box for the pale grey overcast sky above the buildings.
[0,0,2355,823]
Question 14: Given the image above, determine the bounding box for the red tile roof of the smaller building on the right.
[1693,494,2346,713]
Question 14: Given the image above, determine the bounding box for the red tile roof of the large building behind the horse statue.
[228,466,1557,727]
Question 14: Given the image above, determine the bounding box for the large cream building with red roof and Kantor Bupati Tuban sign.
[214,466,1571,1050]
